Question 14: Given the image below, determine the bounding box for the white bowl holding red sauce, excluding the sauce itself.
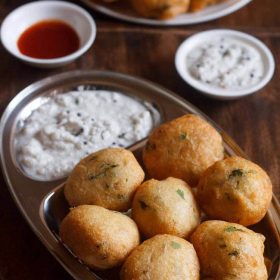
[1,1,96,68]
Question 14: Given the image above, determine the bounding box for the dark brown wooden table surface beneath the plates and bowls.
[0,0,280,280]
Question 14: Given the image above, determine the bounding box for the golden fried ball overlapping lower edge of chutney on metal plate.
[64,148,144,211]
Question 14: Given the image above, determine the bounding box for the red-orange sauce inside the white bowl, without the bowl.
[17,20,80,59]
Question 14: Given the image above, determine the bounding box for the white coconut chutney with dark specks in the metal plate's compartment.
[15,88,154,180]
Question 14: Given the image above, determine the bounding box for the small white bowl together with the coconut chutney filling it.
[175,29,275,100]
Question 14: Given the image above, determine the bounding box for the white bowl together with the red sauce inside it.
[1,1,96,68]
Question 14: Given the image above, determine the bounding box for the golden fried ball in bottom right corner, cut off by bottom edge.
[191,221,267,280]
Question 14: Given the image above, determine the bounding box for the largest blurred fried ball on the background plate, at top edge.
[132,0,190,19]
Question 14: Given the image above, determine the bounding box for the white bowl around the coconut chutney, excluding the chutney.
[175,29,275,100]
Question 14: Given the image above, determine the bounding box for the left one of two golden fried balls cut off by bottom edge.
[120,234,199,280]
